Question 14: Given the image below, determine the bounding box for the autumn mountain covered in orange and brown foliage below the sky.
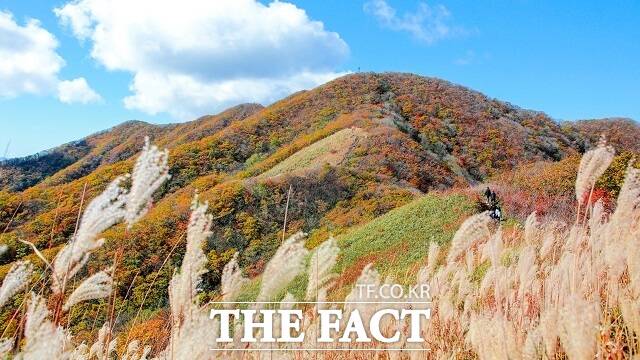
[0,73,638,340]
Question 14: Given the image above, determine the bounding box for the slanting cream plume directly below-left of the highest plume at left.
[52,176,126,293]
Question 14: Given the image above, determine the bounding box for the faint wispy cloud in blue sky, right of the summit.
[364,0,466,44]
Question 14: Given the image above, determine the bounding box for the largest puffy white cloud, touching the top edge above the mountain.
[55,0,349,119]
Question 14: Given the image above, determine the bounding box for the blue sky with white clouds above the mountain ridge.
[0,0,640,157]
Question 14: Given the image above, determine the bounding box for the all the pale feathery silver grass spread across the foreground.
[0,134,640,360]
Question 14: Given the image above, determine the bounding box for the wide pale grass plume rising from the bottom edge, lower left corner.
[20,293,69,360]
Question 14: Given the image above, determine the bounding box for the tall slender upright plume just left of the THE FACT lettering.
[169,194,212,321]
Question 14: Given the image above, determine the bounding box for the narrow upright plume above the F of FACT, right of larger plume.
[305,237,340,301]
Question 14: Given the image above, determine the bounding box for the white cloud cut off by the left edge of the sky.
[0,11,99,102]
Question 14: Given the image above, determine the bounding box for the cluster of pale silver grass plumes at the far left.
[0,139,171,360]
